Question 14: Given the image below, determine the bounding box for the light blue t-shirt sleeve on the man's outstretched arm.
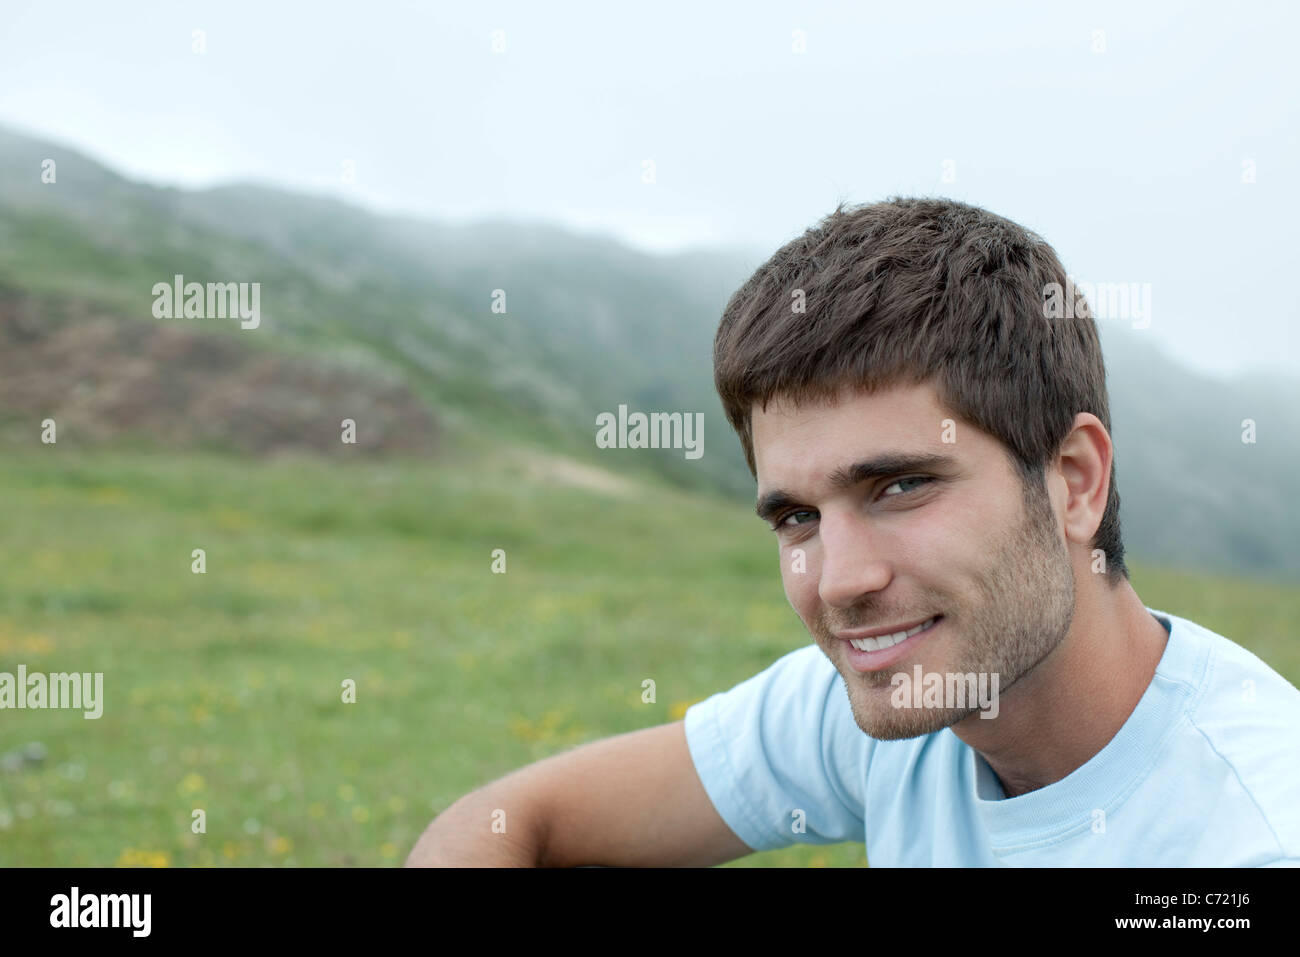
[685,645,874,850]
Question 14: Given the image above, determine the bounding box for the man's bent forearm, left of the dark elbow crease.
[406,779,546,867]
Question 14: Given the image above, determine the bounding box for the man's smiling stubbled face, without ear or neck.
[753,385,1075,740]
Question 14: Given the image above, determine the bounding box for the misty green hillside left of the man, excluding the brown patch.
[0,130,757,494]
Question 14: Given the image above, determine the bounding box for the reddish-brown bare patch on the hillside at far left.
[0,298,438,458]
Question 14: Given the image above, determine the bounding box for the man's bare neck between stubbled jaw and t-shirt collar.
[953,580,1169,797]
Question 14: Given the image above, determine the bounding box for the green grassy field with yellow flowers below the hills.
[0,446,1300,866]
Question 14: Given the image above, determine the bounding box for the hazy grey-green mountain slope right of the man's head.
[1102,325,1300,579]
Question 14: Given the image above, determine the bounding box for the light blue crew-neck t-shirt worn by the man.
[685,609,1300,867]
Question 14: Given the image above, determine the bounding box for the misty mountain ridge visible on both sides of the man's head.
[0,129,1300,577]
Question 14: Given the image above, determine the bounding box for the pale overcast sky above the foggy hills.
[0,0,1300,382]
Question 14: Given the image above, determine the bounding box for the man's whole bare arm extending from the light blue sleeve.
[407,722,754,867]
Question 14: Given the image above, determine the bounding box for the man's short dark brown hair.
[714,198,1128,584]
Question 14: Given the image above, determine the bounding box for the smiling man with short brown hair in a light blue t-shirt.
[408,199,1300,866]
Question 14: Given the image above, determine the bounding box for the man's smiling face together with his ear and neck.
[754,386,1133,754]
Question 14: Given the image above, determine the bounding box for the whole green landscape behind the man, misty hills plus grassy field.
[0,121,1300,866]
